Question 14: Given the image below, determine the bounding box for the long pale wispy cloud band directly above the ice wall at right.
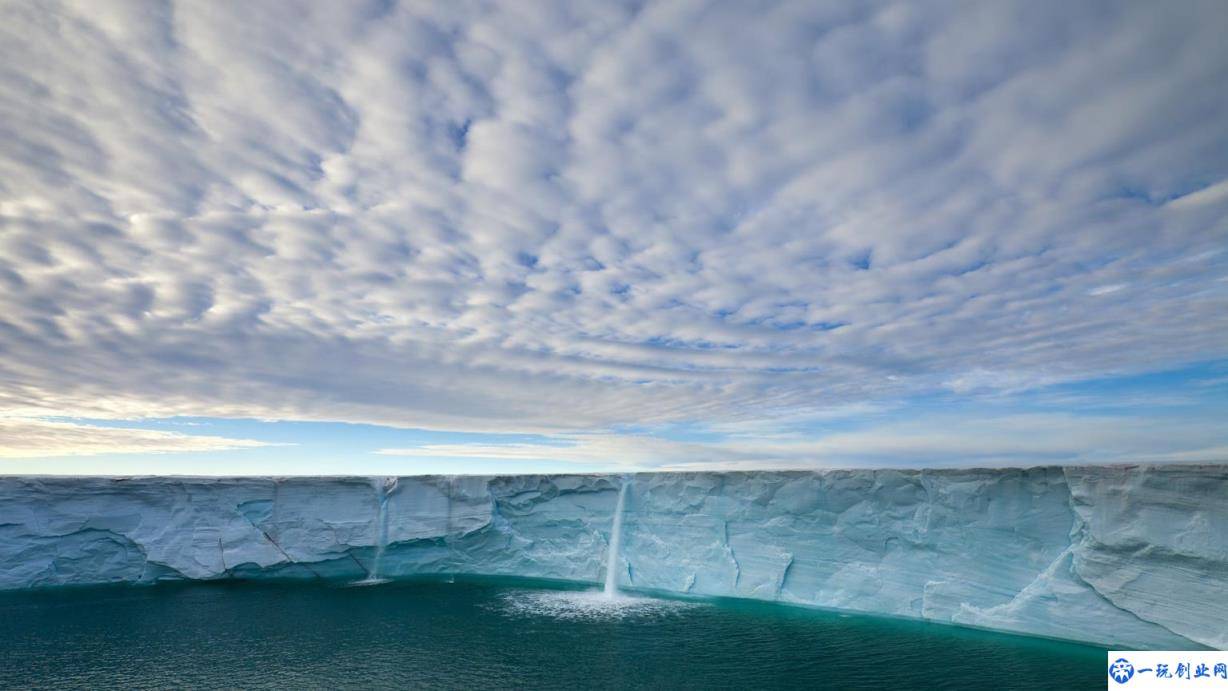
[376,414,1228,470]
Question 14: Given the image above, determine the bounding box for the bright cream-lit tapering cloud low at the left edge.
[0,417,270,458]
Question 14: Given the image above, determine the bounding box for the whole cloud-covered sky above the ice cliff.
[0,0,1228,475]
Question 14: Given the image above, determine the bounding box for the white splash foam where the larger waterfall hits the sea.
[488,590,705,620]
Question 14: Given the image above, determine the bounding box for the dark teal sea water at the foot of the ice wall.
[0,582,1105,689]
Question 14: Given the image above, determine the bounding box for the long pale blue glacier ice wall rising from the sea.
[0,465,1228,649]
